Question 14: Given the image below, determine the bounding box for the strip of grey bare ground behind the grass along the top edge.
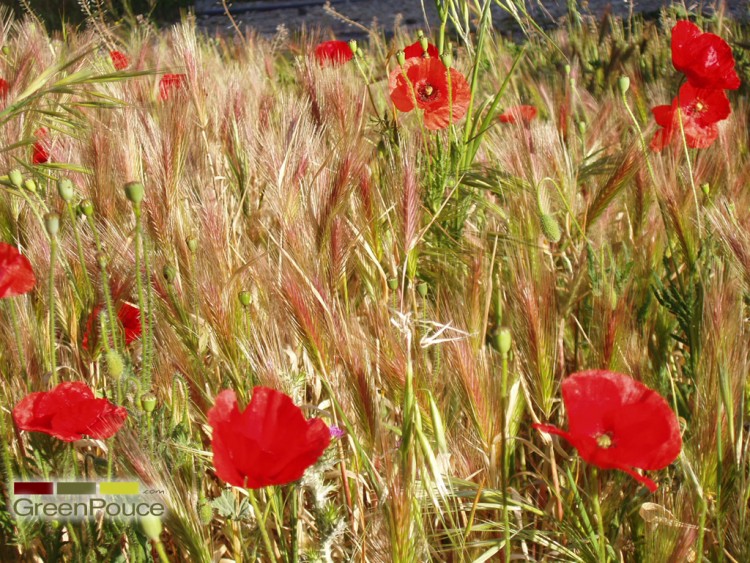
[195,0,750,39]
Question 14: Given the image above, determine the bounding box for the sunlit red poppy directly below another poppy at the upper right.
[651,82,732,151]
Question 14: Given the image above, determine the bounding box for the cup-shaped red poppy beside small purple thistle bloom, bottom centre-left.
[208,387,331,489]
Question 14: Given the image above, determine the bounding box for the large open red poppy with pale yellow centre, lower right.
[534,370,682,492]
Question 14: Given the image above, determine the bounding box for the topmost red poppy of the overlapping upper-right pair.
[672,20,740,90]
